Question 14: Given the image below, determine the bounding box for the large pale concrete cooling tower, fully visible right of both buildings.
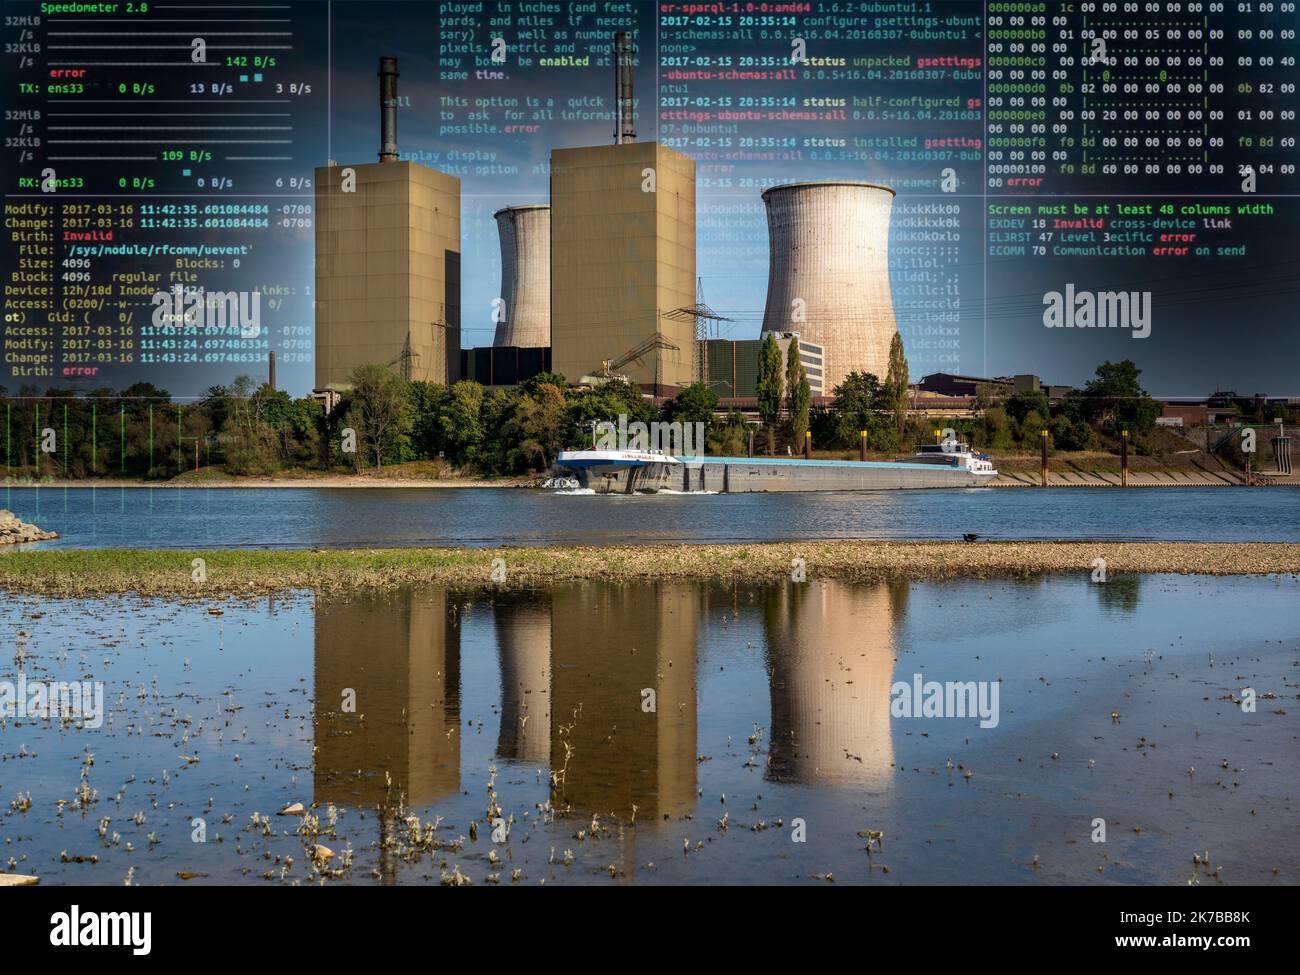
[763,182,898,395]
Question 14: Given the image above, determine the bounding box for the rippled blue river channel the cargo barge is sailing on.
[0,486,1300,549]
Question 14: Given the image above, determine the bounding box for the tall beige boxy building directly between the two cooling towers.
[551,142,696,391]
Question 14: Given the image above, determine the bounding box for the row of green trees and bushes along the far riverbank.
[0,353,1263,481]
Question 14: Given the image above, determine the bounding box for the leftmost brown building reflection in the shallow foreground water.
[313,590,460,807]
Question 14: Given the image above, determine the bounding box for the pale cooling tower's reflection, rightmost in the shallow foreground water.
[762,581,907,790]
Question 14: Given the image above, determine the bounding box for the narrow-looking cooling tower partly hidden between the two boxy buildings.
[493,203,551,347]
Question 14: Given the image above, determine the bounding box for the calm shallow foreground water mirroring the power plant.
[0,577,1300,884]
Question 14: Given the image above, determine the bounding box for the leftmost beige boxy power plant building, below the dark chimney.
[316,163,460,390]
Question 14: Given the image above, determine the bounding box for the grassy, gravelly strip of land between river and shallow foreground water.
[0,541,1300,597]
